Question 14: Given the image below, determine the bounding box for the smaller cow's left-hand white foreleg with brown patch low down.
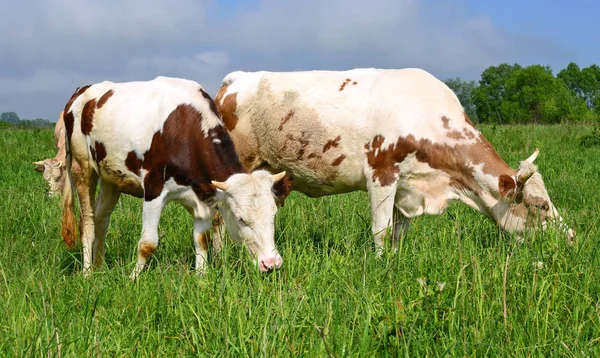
[129,191,166,280]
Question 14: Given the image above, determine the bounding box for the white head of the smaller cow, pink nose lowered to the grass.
[212,170,291,272]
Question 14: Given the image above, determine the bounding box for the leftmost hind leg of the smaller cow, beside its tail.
[73,166,98,276]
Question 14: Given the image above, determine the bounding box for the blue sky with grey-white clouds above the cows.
[0,0,600,121]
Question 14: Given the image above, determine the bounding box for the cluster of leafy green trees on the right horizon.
[444,63,600,124]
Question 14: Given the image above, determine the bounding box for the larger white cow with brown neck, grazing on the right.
[215,69,574,248]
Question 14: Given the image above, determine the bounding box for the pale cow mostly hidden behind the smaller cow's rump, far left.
[33,112,65,197]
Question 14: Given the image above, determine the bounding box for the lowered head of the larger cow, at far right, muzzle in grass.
[497,149,575,239]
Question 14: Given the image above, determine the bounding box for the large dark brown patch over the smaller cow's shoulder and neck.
[142,104,245,201]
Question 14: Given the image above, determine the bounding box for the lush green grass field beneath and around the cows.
[0,125,600,357]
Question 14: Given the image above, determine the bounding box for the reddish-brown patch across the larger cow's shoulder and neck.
[365,134,515,193]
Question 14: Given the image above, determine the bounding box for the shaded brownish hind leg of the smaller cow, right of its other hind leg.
[94,179,121,265]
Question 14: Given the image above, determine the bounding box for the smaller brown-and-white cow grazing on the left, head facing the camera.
[62,77,289,279]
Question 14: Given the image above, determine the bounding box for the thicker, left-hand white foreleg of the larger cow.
[367,182,397,254]
